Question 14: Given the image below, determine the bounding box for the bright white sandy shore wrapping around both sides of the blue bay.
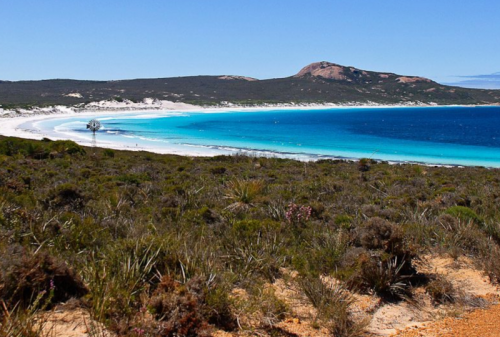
[0,99,497,167]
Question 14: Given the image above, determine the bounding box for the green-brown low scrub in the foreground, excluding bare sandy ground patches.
[0,138,500,336]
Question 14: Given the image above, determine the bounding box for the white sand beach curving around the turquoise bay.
[0,100,495,167]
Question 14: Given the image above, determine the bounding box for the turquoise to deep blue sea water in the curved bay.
[29,107,500,167]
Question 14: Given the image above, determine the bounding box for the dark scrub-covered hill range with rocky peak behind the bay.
[0,62,500,108]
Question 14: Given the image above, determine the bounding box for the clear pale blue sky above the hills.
[0,0,500,87]
